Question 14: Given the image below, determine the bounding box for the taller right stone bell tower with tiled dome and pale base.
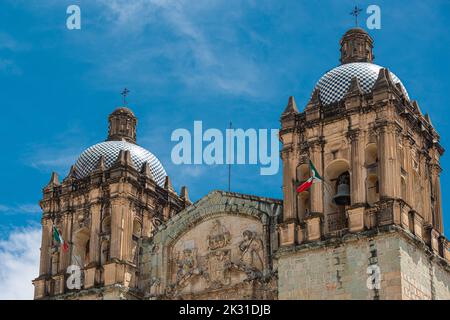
[277,28,450,299]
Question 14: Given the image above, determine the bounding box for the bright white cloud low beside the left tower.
[0,227,41,300]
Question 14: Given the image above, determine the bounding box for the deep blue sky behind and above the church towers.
[0,0,450,298]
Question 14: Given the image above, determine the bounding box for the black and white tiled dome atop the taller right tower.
[314,62,409,105]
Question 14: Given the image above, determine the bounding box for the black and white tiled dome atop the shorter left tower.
[75,141,166,187]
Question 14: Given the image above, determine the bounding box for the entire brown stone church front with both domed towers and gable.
[33,28,450,299]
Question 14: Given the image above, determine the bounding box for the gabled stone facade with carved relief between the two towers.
[141,191,282,299]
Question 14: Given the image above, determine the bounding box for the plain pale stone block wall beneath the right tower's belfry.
[278,229,450,299]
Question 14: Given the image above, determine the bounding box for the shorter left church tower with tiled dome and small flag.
[33,107,190,299]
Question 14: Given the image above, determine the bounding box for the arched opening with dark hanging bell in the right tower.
[324,159,351,232]
